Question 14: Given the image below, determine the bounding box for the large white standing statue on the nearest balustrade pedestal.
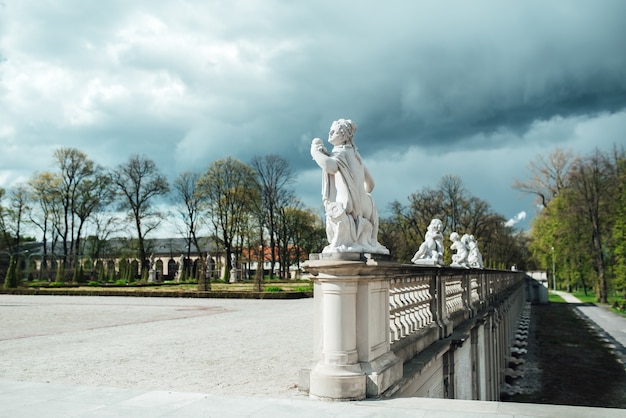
[311,119,389,254]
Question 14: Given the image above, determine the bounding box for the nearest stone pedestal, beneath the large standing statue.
[305,254,402,400]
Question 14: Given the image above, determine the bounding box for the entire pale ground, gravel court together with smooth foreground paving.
[0,295,626,418]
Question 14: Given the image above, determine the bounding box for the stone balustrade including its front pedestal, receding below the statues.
[300,254,525,400]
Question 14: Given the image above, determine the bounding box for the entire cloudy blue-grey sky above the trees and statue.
[0,0,626,235]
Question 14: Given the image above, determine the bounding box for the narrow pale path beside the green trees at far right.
[556,292,626,367]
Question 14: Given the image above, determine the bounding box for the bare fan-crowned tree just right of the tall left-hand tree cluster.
[111,155,169,271]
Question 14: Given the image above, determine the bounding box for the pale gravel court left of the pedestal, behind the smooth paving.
[0,295,313,397]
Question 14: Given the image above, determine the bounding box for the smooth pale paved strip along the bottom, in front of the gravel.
[0,379,626,418]
